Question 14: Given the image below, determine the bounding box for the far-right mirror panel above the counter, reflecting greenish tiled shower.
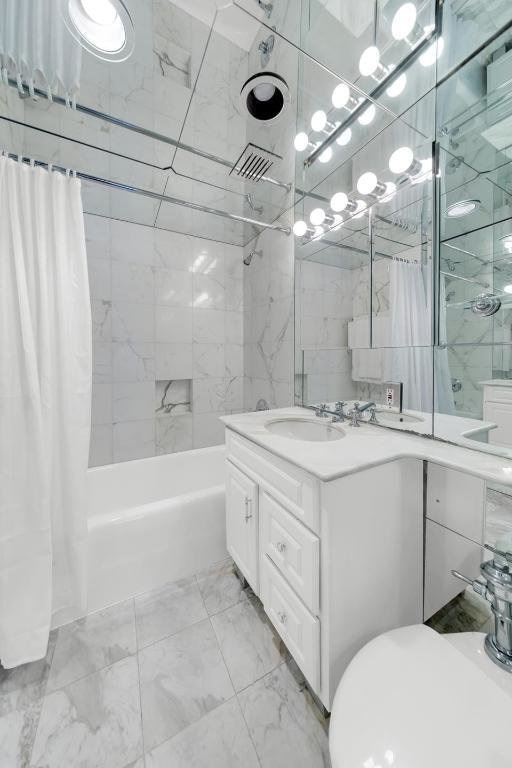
[434,21,512,456]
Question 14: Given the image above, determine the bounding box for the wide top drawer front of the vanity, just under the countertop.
[226,429,320,533]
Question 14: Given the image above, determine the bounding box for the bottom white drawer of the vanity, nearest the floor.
[261,556,320,690]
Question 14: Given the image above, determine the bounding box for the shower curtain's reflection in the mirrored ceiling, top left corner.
[0,0,82,102]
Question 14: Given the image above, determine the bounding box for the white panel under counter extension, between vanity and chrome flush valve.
[424,462,485,620]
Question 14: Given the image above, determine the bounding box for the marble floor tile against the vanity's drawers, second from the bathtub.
[211,599,285,691]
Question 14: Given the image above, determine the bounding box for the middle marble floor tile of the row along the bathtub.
[135,578,207,648]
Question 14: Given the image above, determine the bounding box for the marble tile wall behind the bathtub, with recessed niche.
[85,215,244,466]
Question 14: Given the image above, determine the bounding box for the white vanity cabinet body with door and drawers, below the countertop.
[226,428,423,710]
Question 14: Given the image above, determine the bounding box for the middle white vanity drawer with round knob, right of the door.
[259,491,320,614]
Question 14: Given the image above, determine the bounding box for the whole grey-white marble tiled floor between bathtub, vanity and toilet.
[0,562,330,768]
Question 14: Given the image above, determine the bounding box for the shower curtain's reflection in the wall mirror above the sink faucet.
[390,260,432,413]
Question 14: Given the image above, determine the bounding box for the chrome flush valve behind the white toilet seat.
[452,544,512,672]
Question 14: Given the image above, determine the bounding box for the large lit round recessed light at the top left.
[62,0,135,61]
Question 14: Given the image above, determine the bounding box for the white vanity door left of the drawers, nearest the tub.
[226,461,259,594]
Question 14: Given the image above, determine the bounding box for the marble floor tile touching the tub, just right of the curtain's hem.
[46,600,137,693]
